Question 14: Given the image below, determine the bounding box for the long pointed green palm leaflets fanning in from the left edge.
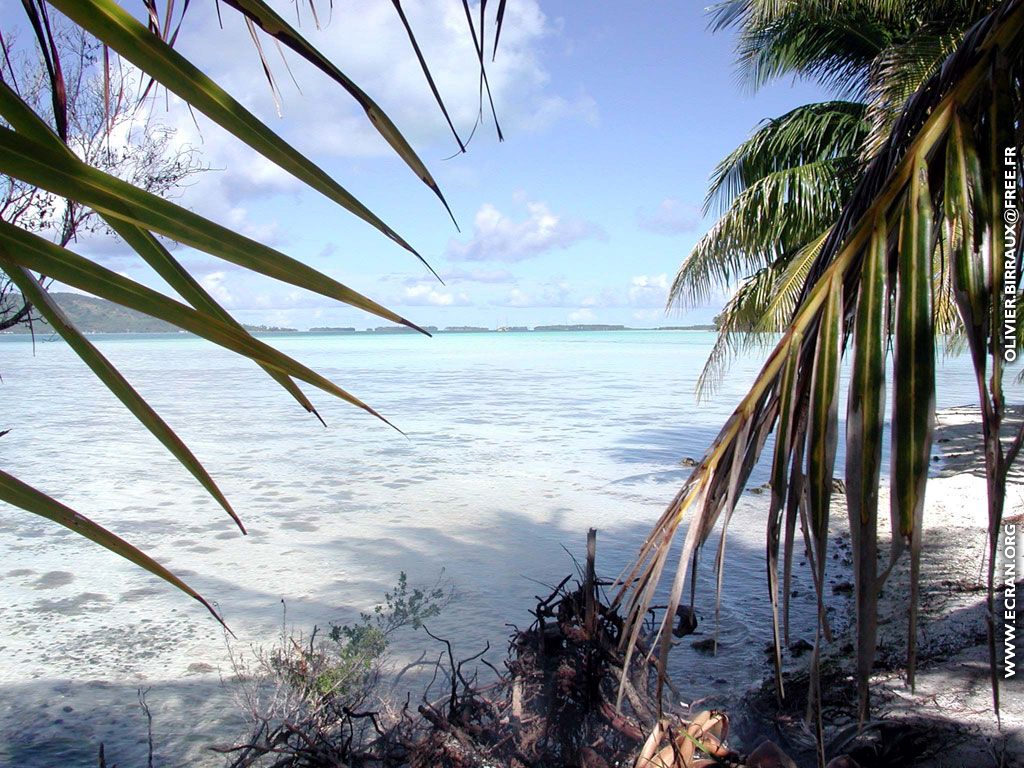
[0,0,495,622]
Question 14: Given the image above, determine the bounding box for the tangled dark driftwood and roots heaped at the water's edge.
[221,531,856,768]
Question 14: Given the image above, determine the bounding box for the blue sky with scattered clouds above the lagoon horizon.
[0,0,821,329]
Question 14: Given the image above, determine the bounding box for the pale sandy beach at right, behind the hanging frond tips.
[873,408,1024,766]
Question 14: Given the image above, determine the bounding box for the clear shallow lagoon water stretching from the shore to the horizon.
[0,332,991,767]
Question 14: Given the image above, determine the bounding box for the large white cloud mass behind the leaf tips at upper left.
[110,0,597,262]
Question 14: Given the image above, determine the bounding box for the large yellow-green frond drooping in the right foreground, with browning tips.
[615,0,1024,733]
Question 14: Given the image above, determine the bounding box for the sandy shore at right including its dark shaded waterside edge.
[740,407,1024,768]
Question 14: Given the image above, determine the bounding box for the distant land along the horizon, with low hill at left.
[4,291,716,335]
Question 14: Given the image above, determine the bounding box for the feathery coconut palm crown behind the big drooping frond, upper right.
[669,0,995,394]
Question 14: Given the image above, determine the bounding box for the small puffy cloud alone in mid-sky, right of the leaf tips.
[446,202,605,262]
